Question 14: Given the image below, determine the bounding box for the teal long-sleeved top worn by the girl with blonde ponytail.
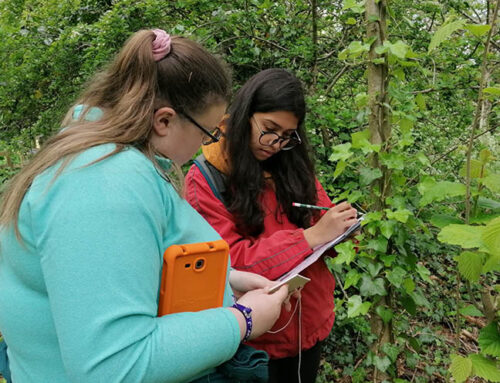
[0,145,240,383]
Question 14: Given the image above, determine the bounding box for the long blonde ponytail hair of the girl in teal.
[0,30,231,238]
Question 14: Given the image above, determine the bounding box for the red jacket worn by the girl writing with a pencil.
[185,165,335,359]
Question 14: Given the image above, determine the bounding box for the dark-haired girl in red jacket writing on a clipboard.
[186,69,356,383]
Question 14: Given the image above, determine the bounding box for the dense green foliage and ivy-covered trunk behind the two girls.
[0,0,500,382]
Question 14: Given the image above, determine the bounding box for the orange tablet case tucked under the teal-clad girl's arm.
[158,239,229,316]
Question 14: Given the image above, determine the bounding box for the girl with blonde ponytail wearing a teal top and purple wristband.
[0,30,287,383]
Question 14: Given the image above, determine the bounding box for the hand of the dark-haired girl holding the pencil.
[304,202,357,248]
